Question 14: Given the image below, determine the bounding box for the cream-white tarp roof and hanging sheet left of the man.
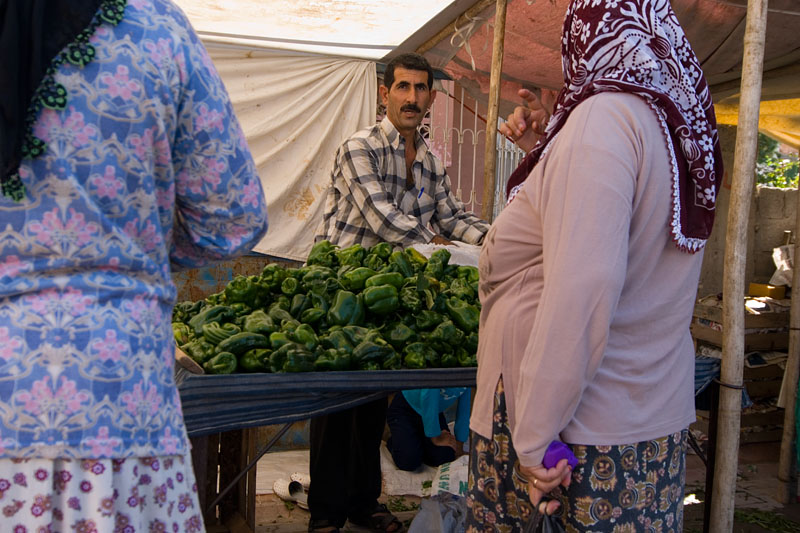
[176,0,482,260]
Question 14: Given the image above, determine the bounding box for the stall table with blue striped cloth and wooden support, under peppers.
[175,367,477,532]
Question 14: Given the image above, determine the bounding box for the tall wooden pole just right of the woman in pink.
[710,0,767,533]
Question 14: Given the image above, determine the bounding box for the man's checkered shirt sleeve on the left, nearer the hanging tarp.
[336,139,438,244]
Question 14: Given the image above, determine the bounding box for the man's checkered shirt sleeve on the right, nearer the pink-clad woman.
[433,161,489,244]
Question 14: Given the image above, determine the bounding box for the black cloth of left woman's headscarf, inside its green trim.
[0,0,101,197]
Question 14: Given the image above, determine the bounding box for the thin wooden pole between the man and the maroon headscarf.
[481,0,506,222]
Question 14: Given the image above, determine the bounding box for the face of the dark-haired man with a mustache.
[380,67,436,136]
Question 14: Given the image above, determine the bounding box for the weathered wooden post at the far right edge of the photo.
[777,159,800,505]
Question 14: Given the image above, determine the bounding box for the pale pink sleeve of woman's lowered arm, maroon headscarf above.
[512,97,640,466]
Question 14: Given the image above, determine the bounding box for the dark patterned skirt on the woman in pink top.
[467,378,687,533]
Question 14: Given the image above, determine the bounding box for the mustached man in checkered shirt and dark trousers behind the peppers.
[308,54,489,532]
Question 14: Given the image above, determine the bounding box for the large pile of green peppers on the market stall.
[172,241,480,374]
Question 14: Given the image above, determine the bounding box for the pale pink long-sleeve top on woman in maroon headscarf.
[470,93,702,466]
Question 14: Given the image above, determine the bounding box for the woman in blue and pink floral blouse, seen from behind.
[0,0,267,532]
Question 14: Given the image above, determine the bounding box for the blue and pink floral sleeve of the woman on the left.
[170,23,267,269]
